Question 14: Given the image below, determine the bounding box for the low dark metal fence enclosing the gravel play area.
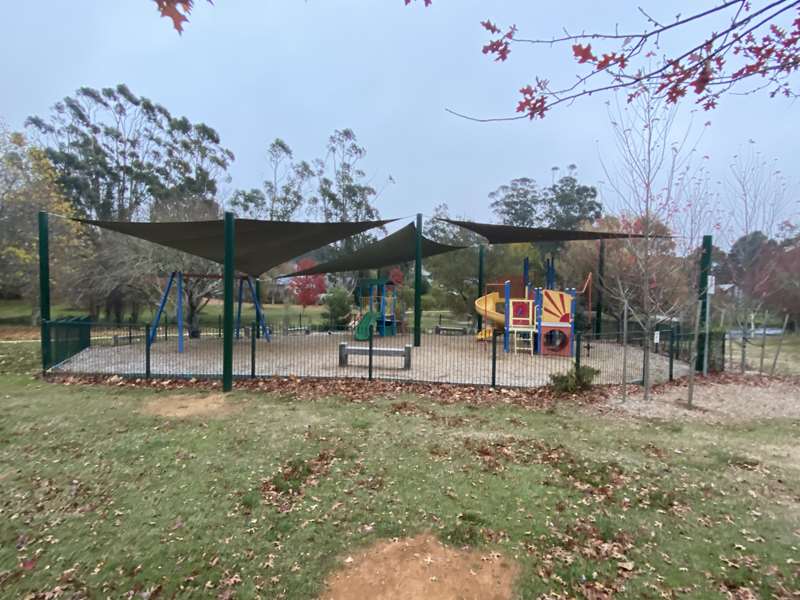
[46,320,725,387]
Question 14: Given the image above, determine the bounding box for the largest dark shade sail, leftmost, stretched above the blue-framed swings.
[76,219,395,277]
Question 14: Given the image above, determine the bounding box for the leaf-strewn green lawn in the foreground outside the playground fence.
[0,344,800,598]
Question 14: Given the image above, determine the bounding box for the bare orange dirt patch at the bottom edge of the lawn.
[321,534,519,600]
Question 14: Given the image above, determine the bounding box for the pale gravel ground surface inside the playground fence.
[54,331,688,387]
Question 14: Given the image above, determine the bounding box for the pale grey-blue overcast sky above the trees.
[0,0,800,232]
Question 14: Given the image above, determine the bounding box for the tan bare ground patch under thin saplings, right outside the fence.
[606,375,800,422]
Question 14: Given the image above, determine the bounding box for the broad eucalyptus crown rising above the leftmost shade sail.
[26,84,234,221]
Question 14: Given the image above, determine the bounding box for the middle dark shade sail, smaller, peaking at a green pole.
[283,223,464,277]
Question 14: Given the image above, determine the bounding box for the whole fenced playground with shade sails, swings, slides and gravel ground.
[40,213,721,390]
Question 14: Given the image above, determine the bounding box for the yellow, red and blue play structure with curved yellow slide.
[475,258,580,356]
